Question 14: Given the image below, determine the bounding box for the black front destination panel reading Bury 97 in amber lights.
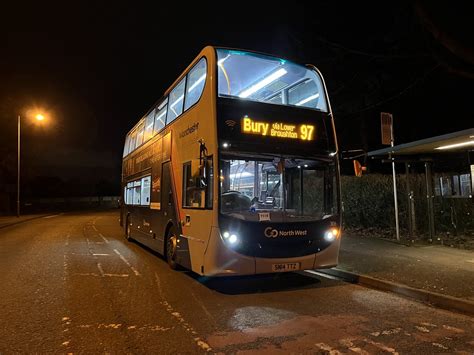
[217,97,336,156]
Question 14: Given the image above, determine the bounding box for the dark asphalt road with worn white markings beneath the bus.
[0,211,474,354]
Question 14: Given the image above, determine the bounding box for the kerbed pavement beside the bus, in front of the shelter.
[320,235,474,314]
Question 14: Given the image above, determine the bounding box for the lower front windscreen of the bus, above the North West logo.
[220,157,338,222]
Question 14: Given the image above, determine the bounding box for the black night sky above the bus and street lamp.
[0,1,474,196]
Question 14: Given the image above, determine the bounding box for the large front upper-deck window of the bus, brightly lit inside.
[217,49,328,112]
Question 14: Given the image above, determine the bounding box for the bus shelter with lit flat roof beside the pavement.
[367,128,474,242]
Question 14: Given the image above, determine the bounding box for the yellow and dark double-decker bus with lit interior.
[120,46,341,276]
